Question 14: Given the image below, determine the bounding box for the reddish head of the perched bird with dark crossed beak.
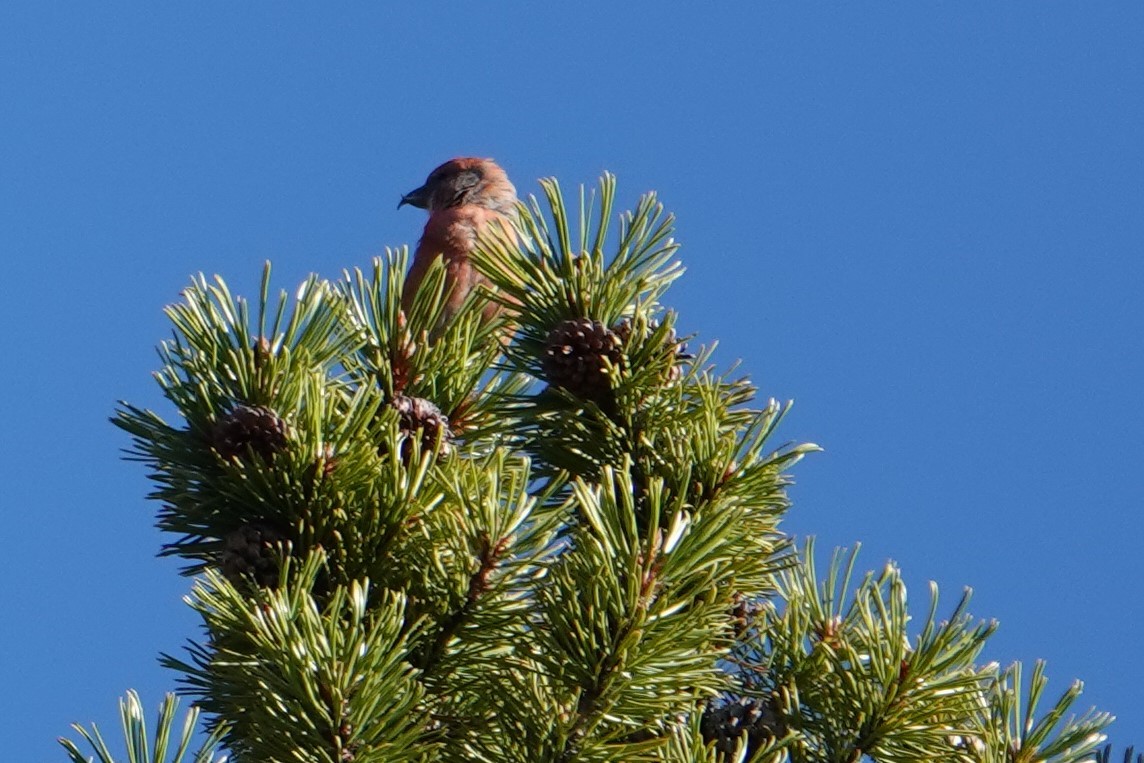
[397,157,516,214]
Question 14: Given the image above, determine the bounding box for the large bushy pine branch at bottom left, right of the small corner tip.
[164,554,434,763]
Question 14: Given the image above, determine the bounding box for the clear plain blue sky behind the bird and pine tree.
[0,0,1144,762]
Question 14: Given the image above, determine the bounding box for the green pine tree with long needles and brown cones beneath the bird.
[64,176,1111,763]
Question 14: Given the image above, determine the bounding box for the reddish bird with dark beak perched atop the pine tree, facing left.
[397,157,516,325]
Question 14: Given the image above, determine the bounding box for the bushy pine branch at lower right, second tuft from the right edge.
[736,542,994,763]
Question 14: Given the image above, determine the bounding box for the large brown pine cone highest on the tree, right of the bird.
[543,318,623,402]
